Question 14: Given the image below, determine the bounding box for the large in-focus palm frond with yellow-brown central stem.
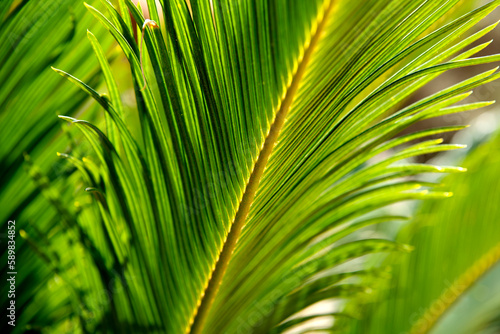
[0,0,500,334]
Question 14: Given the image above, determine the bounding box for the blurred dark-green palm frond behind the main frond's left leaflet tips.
[0,0,112,332]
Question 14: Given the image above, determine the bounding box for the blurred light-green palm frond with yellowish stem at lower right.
[356,129,500,333]
